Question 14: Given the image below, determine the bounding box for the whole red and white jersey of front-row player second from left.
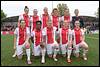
[31,29,42,46]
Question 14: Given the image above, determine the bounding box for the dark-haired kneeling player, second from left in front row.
[31,21,46,63]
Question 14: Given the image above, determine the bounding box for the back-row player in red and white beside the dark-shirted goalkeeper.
[61,9,72,28]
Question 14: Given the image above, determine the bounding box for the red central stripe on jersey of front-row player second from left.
[35,29,42,46]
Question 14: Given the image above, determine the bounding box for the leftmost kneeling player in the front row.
[14,20,32,64]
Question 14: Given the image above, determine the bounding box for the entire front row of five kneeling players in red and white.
[14,20,88,64]
